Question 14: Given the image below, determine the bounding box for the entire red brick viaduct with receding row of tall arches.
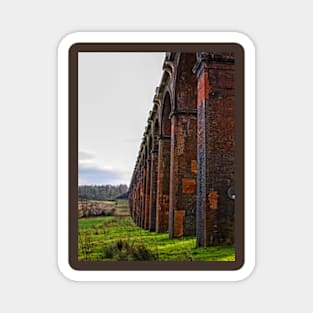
[129,52,235,247]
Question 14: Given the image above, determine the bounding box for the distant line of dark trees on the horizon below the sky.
[78,184,128,201]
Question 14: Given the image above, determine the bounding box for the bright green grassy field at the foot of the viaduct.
[78,200,235,261]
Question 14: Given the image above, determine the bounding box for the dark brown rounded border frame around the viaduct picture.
[68,42,244,271]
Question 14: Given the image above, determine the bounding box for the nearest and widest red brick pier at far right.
[197,53,235,246]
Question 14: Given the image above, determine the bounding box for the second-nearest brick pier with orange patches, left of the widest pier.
[169,53,197,237]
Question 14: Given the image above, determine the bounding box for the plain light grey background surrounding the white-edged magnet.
[0,0,313,312]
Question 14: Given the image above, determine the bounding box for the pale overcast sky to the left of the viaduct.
[78,52,165,185]
